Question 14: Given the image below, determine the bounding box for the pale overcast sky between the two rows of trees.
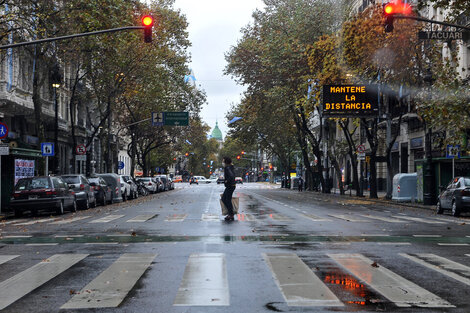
[175,0,264,138]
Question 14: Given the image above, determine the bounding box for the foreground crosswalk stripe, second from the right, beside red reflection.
[328,254,454,308]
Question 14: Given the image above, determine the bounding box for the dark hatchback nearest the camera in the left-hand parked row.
[10,176,77,217]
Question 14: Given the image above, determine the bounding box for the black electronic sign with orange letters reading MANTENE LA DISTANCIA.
[322,85,379,117]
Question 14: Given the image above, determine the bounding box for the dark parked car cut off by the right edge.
[437,177,470,216]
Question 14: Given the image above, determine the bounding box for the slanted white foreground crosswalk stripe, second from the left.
[61,253,157,309]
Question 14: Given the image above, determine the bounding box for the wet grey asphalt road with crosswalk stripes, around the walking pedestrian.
[0,183,470,313]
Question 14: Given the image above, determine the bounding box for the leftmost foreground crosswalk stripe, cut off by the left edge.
[0,254,88,310]
